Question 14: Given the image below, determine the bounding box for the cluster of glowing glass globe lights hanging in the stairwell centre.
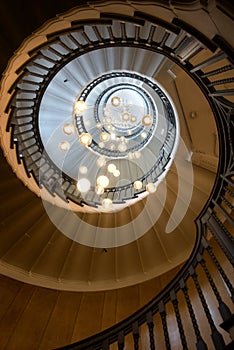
[59,96,156,209]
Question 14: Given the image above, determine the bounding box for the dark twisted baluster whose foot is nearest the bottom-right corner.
[189,266,225,350]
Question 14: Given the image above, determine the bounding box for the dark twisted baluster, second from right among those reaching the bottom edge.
[180,280,208,350]
